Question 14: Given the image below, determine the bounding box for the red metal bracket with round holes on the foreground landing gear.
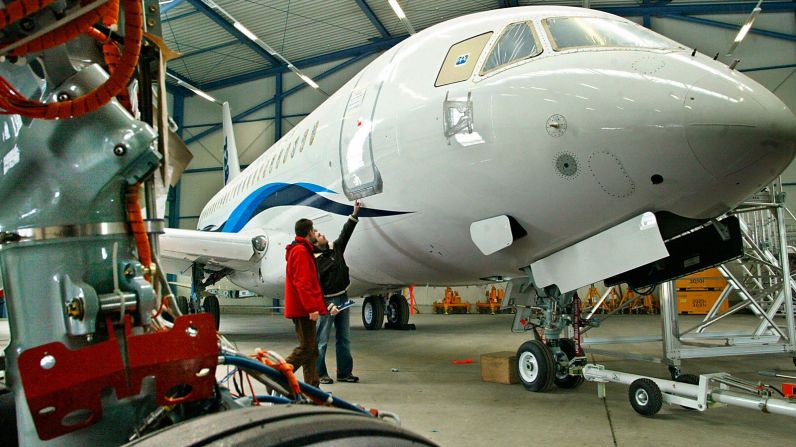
[18,313,218,440]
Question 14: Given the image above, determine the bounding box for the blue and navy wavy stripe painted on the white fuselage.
[210,183,409,233]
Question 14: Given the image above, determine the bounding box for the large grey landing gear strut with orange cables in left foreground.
[0,0,436,446]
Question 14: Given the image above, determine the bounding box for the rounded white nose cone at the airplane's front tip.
[684,76,796,178]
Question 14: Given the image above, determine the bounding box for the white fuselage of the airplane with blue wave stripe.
[193,7,796,297]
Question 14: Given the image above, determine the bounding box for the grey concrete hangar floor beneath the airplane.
[0,308,794,447]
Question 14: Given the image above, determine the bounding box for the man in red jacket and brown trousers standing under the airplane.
[285,219,326,386]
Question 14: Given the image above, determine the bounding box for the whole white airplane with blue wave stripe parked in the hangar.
[161,6,796,391]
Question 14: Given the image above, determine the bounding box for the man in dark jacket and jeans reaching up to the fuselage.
[315,200,361,384]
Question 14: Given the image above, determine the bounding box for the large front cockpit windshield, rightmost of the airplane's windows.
[544,17,680,51]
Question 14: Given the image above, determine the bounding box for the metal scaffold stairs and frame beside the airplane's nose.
[583,185,796,374]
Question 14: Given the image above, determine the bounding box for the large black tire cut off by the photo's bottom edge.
[127,405,436,447]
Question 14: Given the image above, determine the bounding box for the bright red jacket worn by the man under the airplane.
[285,236,326,318]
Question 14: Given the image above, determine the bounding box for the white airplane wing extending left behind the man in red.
[160,228,268,271]
